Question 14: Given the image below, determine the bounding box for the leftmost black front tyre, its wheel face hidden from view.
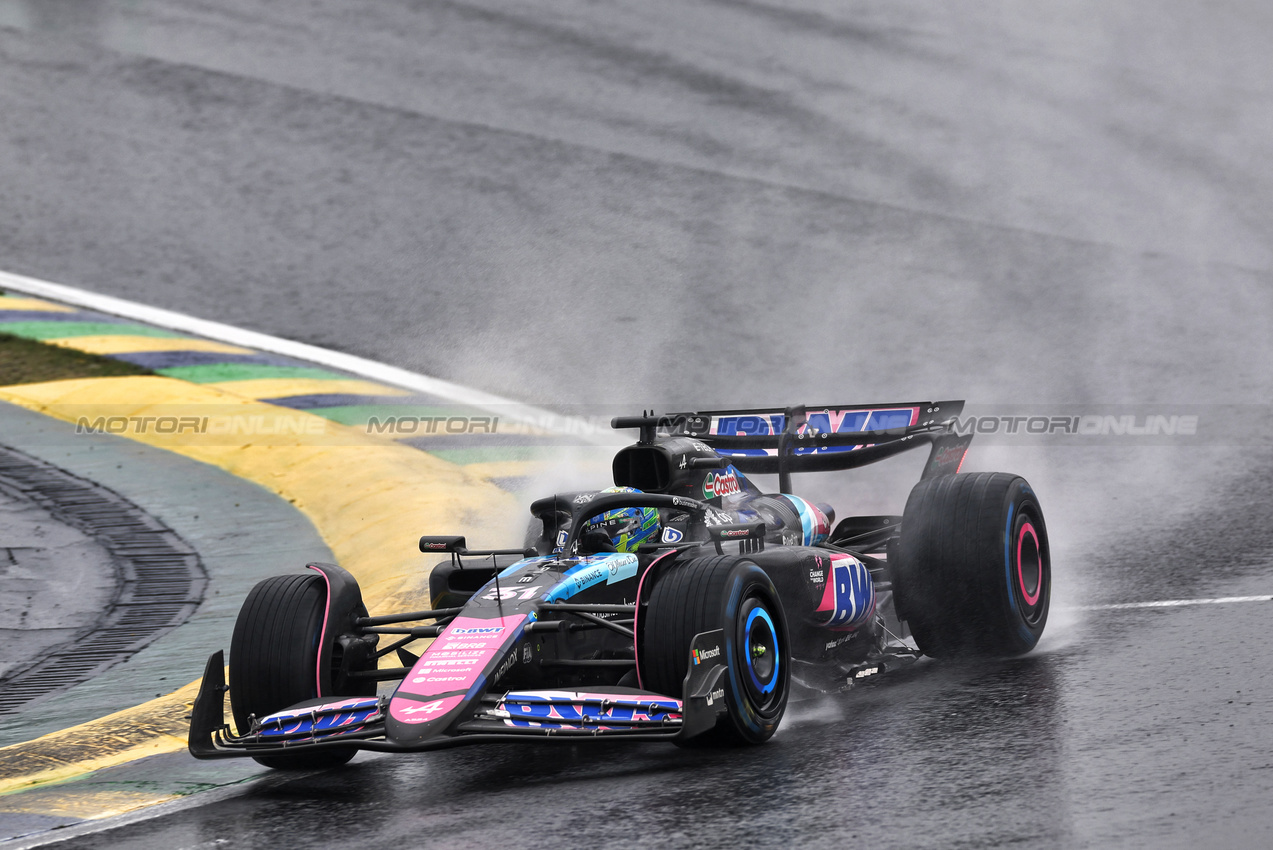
[229,573,376,770]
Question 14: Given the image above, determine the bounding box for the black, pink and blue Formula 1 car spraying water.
[190,401,1051,769]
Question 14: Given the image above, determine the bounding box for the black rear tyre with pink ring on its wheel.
[892,472,1051,658]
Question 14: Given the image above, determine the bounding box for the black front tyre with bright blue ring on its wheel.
[639,555,791,744]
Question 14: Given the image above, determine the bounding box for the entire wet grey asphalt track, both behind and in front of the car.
[0,0,1273,847]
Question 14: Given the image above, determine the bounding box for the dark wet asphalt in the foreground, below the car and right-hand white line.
[54,564,1273,849]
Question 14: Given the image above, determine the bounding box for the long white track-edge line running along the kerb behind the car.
[0,271,596,438]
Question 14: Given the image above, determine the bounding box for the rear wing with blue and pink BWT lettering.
[611,400,973,492]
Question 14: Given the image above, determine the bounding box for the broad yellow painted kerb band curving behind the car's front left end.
[0,375,516,793]
